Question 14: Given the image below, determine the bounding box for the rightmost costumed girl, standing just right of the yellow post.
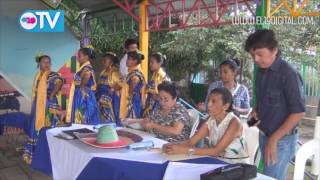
[143,52,170,117]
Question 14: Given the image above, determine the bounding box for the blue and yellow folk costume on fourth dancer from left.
[120,66,145,120]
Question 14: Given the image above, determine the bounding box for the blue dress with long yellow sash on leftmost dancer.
[23,71,63,164]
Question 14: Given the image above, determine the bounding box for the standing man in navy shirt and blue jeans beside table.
[245,29,305,180]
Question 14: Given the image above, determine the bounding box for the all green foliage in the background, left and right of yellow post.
[51,0,320,88]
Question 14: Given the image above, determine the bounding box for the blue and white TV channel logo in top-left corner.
[19,10,64,32]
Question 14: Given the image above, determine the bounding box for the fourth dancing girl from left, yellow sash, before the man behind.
[120,51,145,120]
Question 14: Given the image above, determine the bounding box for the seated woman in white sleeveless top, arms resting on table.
[163,88,249,163]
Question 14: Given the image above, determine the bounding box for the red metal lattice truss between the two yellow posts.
[146,0,256,31]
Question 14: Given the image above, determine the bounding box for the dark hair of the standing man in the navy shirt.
[245,29,278,52]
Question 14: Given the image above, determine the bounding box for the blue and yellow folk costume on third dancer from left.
[97,67,121,124]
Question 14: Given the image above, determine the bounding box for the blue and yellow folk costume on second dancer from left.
[66,61,100,124]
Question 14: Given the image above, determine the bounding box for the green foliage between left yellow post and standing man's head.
[151,25,252,80]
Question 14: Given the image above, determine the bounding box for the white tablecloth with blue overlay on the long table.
[47,124,270,180]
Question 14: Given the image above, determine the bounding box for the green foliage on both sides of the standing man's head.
[151,17,320,84]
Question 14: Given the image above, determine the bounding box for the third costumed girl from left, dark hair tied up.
[97,52,121,124]
